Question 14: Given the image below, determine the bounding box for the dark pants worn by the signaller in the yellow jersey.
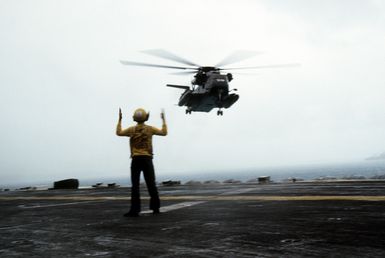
[130,156,160,212]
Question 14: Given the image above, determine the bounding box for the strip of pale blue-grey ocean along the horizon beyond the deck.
[0,160,385,189]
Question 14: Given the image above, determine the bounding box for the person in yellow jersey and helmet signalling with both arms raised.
[116,108,167,217]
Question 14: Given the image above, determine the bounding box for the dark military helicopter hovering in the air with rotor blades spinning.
[120,49,298,116]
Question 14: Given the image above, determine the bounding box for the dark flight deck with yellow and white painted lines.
[0,180,385,257]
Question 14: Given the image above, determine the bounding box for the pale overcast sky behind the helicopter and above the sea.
[0,0,385,183]
